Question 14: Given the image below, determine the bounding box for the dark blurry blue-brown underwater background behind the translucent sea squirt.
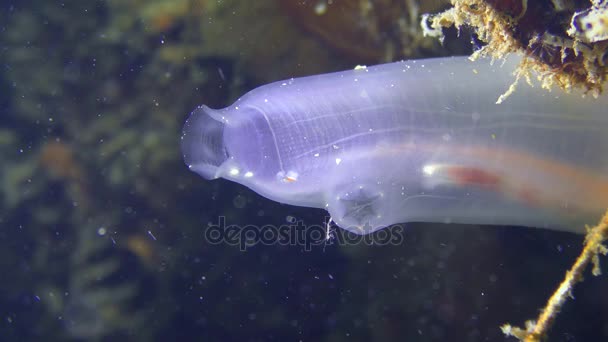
[0,0,608,341]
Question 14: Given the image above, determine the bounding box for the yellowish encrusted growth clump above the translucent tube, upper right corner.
[422,0,608,99]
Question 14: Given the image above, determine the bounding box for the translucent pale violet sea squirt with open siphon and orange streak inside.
[181,56,608,234]
